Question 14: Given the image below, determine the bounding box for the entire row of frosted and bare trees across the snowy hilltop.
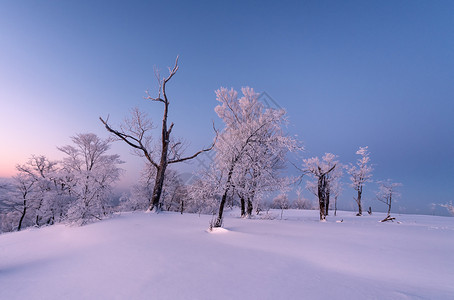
[0,58,400,231]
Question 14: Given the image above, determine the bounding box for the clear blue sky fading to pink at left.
[0,0,454,213]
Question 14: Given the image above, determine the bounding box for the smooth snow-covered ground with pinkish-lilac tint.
[0,210,454,300]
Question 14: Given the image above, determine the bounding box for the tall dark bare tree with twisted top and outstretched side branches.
[100,57,214,212]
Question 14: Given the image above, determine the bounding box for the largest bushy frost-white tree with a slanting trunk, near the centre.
[214,87,296,227]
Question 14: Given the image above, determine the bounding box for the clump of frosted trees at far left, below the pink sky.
[1,133,123,231]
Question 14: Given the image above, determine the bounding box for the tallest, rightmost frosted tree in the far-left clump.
[58,133,123,225]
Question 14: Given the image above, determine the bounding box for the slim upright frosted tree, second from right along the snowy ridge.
[347,146,373,216]
